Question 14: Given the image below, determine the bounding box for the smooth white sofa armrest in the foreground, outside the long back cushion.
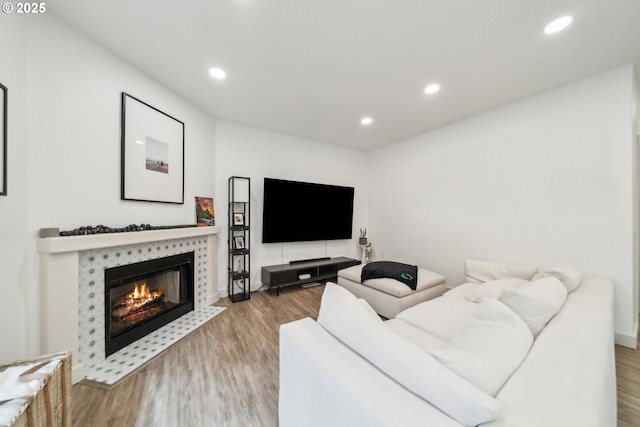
[279,318,461,427]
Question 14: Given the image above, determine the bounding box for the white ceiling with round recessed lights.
[47,0,640,150]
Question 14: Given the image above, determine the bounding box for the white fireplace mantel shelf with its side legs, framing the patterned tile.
[37,226,220,383]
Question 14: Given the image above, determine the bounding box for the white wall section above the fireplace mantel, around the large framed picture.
[29,18,215,229]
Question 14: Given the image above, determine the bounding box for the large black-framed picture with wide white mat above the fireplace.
[121,92,184,204]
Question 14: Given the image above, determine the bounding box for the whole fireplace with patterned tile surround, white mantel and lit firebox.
[38,227,220,382]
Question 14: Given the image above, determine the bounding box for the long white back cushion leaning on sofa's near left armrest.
[318,283,499,426]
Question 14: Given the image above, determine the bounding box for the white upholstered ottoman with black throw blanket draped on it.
[338,265,446,319]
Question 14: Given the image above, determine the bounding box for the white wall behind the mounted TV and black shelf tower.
[214,120,368,290]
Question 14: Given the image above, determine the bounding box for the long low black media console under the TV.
[262,257,360,296]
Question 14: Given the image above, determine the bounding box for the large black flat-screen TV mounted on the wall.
[262,178,354,243]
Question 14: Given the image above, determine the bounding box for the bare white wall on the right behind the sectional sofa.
[369,66,636,344]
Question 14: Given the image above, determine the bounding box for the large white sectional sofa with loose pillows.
[279,262,617,427]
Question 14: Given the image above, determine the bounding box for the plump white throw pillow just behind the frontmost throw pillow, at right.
[499,277,567,336]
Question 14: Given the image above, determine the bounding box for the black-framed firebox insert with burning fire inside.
[105,252,194,356]
